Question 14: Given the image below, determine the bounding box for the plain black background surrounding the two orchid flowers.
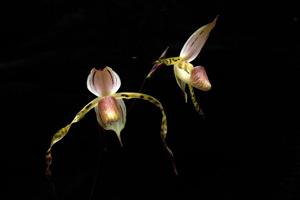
[0,0,300,200]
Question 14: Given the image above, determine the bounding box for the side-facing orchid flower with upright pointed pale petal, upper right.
[146,16,218,113]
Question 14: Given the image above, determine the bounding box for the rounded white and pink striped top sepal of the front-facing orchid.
[87,67,121,96]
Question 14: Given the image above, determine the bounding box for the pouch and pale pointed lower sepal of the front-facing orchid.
[95,96,126,146]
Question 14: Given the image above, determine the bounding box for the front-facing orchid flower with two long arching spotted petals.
[46,67,177,175]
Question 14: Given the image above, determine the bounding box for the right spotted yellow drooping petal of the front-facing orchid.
[114,92,178,175]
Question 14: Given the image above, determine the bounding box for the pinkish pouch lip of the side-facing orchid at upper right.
[190,66,211,91]
